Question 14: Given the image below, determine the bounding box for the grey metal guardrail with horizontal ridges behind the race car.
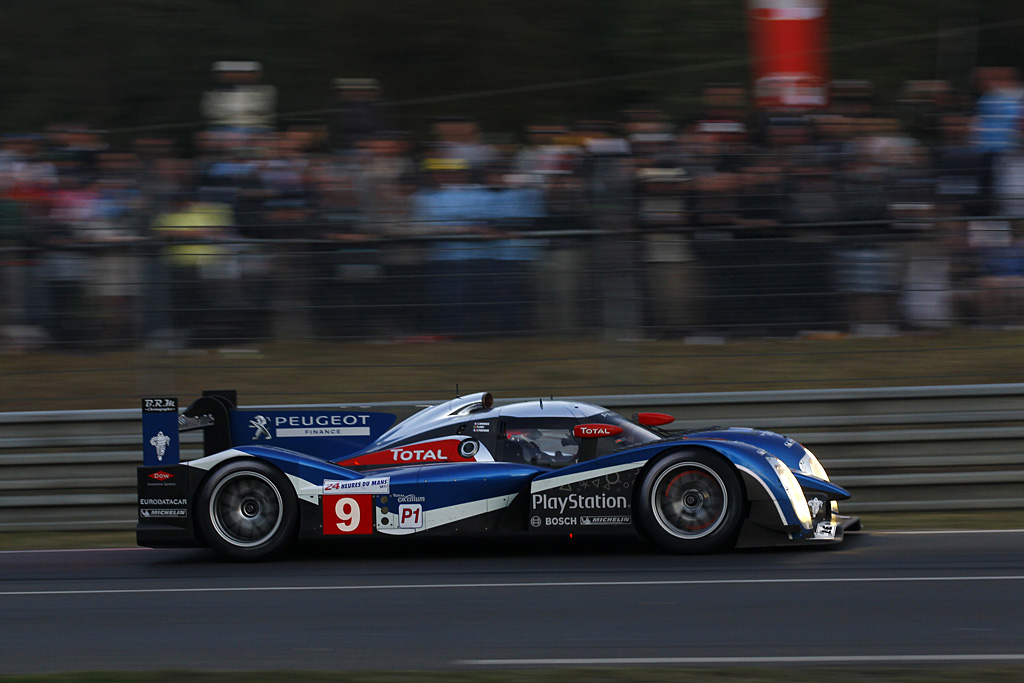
[0,384,1024,530]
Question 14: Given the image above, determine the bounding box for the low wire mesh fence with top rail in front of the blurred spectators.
[6,217,1024,349]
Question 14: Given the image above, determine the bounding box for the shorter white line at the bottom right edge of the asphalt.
[453,653,1024,667]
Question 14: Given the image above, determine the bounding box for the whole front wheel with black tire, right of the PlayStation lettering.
[636,451,746,555]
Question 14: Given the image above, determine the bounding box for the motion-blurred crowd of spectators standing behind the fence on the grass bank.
[0,62,1024,347]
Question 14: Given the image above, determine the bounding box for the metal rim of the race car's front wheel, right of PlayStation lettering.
[650,463,729,539]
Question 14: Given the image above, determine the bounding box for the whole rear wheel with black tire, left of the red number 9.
[195,460,299,560]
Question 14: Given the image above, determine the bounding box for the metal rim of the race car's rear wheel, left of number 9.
[210,472,285,548]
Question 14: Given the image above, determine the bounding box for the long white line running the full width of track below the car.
[0,574,1024,597]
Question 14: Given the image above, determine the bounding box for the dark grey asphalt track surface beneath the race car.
[0,531,1024,674]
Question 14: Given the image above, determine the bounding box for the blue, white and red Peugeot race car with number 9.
[136,391,860,560]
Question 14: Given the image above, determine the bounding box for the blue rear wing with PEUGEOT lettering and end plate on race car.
[142,390,395,467]
